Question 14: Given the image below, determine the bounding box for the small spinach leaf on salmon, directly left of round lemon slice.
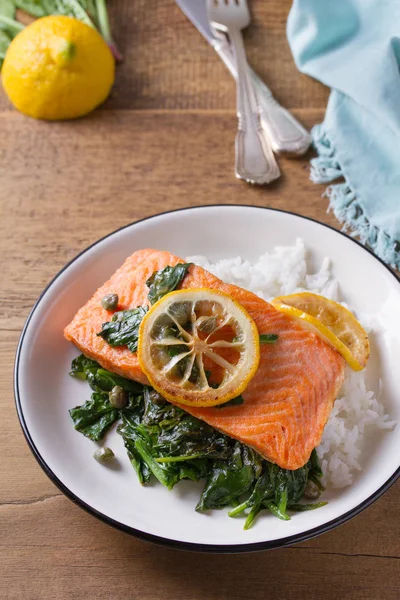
[97,306,147,352]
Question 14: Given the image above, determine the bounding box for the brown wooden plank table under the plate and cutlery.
[0,0,400,600]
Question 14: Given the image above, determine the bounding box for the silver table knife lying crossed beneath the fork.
[176,0,311,156]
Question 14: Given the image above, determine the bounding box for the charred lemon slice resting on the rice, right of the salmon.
[272,292,370,371]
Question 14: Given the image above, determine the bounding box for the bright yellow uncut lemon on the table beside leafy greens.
[2,16,115,121]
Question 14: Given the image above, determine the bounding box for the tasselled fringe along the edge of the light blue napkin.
[310,124,400,269]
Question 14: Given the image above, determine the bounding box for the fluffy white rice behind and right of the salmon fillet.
[187,240,396,488]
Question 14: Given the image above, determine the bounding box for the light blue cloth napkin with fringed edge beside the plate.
[287,0,400,268]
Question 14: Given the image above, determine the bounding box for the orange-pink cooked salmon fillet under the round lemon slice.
[64,249,345,470]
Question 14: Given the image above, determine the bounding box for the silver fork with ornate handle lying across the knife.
[207,0,280,185]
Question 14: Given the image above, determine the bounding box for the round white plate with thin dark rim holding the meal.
[15,205,400,552]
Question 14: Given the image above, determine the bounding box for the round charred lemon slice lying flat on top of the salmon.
[138,288,260,407]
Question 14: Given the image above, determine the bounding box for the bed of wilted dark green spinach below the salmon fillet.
[70,355,326,529]
